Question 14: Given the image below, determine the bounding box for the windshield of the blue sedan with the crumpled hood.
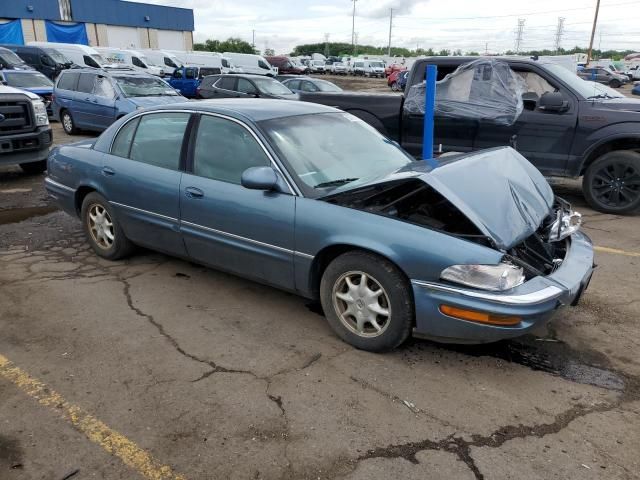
[260,113,413,198]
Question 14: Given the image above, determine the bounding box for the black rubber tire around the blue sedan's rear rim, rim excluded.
[80,192,134,260]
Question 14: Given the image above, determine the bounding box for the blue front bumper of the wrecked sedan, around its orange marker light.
[411,232,594,343]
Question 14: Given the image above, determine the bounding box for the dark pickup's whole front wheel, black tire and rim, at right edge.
[582,150,640,214]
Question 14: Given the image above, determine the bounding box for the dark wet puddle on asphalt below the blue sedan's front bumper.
[446,336,625,391]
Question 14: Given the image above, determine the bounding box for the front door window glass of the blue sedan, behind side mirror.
[193,115,270,185]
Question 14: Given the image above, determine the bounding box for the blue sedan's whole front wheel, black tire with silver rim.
[320,250,414,352]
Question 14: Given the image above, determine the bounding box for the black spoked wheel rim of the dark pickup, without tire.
[592,162,640,207]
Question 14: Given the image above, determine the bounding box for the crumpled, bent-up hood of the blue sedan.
[421,147,554,250]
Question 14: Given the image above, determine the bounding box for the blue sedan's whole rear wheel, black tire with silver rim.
[80,192,134,260]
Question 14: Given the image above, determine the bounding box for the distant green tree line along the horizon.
[193,37,634,60]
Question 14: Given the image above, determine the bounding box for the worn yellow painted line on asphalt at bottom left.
[0,354,186,480]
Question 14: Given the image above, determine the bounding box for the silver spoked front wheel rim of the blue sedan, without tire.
[332,271,391,338]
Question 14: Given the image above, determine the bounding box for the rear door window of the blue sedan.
[129,113,189,170]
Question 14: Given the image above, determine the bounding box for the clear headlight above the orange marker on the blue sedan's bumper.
[440,262,524,291]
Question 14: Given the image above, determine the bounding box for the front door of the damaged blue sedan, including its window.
[180,115,295,289]
